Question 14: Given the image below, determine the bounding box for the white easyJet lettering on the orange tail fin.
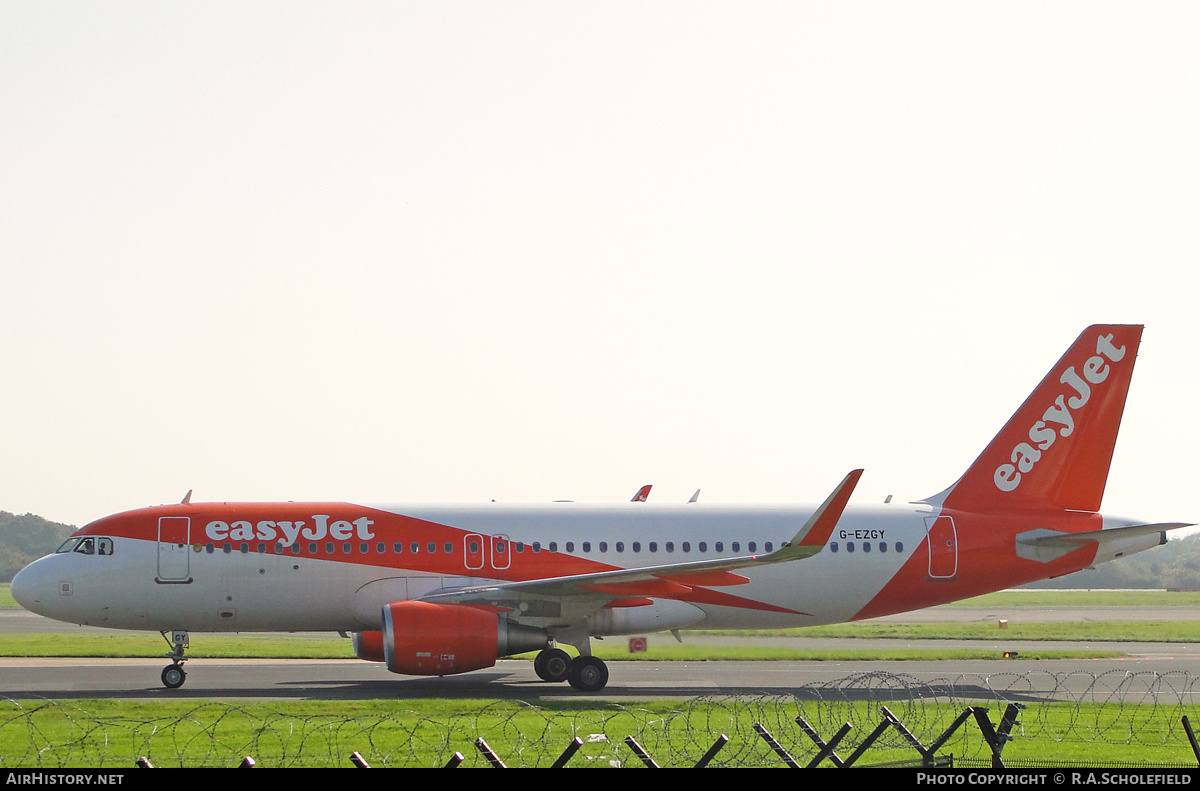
[994,334,1126,492]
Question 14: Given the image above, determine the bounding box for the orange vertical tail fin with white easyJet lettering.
[929,324,1142,513]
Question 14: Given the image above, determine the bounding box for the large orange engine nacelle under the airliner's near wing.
[379,601,550,676]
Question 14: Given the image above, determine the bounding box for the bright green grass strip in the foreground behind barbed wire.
[0,699,1196,768]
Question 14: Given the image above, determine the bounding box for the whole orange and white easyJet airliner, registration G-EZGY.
[12,325,1183,691]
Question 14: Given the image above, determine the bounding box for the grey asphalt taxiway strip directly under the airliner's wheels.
[7,657,1200,702]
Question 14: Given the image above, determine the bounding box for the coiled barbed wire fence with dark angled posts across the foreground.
[0,671,1200,768]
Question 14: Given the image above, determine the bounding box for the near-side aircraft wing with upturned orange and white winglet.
[420,469,863,617]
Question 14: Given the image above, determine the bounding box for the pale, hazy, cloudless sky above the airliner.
[0,0,1200,525]
